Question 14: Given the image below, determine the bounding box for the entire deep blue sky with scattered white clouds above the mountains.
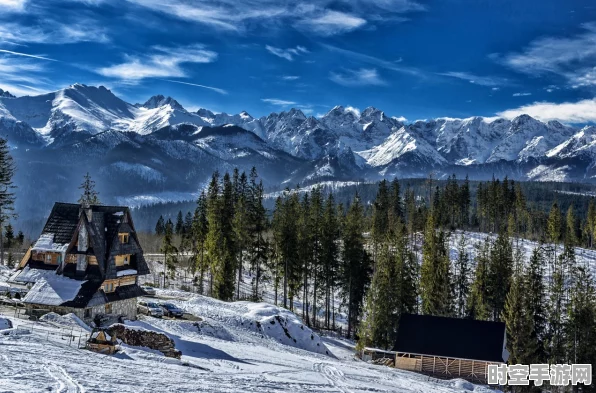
[0,0,596,123]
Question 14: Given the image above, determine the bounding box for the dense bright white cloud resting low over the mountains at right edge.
[498,99,596,123]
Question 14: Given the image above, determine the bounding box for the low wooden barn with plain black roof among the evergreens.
[392,314,509,383]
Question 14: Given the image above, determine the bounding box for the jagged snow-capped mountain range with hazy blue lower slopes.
[0,84,596,230]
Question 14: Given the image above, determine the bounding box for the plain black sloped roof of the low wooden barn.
[393,314,505,362]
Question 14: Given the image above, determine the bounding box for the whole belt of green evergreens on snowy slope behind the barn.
[156,169,596,378]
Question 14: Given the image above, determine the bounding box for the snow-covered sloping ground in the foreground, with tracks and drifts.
[0,291,498,393]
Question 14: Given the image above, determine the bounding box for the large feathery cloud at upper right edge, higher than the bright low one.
[500,23,596,87]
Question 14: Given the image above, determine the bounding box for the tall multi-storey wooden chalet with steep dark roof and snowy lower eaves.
[11,203,149,322]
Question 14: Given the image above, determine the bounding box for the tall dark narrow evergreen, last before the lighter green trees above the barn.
[341,193,371,338]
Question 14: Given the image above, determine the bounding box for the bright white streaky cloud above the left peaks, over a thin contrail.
[97,45,217,80]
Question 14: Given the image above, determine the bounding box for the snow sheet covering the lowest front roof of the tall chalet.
[23,274,86,306]
